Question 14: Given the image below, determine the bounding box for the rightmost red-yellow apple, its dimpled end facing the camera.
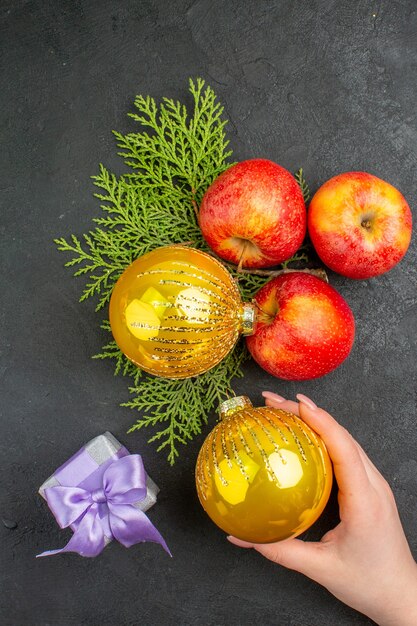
[308,172,411,278]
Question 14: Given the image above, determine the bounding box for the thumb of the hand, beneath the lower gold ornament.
[227,536,329,583]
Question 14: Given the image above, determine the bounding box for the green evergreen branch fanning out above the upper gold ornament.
[55,79,231,310]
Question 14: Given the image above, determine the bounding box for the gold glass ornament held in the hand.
[196,396,333,543]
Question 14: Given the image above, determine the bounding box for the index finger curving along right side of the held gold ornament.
[297,394,370,514]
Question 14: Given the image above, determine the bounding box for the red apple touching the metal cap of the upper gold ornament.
[246,272,355,380]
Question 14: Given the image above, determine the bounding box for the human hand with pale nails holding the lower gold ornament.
[228,391,417,626]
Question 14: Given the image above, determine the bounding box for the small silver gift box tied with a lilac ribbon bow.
[38,432,171,557]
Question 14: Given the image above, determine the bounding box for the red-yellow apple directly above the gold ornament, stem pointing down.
[199,159,307,267]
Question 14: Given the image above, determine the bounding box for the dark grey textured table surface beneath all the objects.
[0,0,417,626]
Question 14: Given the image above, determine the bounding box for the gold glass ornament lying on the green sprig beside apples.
[110,246,255,378]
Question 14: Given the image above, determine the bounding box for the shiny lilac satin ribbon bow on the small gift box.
[37,454,172,557]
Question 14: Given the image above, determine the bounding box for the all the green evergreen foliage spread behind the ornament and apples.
[55,79,309,464]
